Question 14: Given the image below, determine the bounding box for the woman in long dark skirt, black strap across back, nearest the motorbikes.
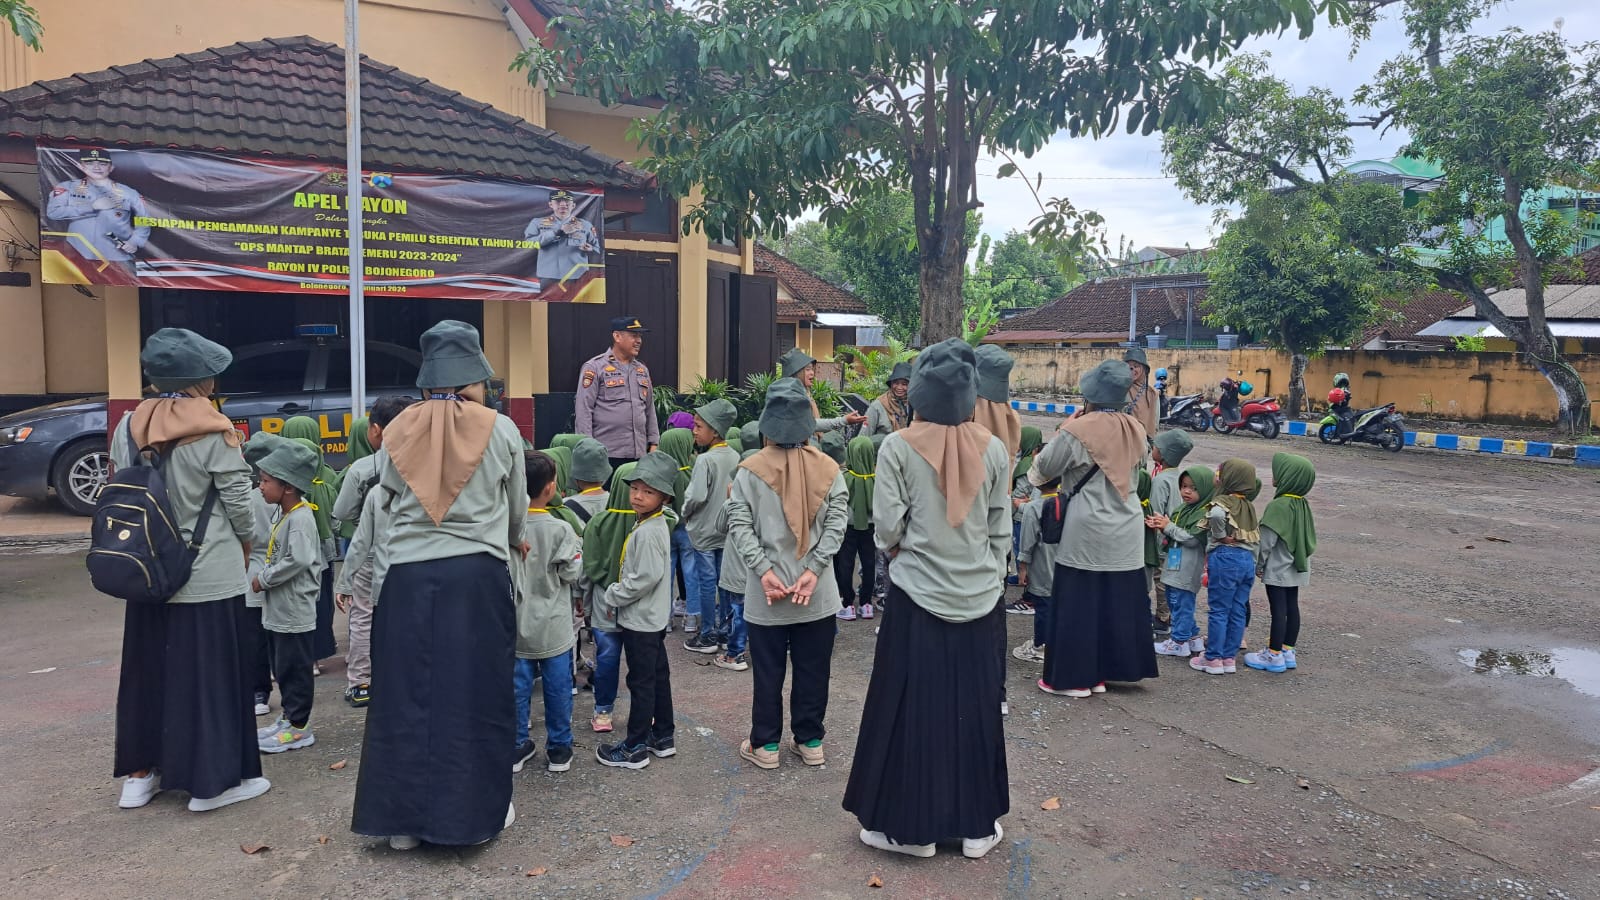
[1027,360,1158,697]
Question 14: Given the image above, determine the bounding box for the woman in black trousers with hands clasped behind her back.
[728,381,850,769]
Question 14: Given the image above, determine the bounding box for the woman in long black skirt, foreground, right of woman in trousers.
[843,338,1011,858]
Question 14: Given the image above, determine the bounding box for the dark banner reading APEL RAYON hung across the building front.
[38,147,605,303]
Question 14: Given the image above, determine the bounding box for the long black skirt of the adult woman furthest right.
[1045,565,1160,689]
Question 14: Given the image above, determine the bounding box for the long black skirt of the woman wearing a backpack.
[112,594,261,799]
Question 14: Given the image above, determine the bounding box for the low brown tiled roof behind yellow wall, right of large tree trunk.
[994,275,1210,341]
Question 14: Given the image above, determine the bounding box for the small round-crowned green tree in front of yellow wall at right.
[1206,191,1381,416]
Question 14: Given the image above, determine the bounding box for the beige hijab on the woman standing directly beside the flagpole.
[384,384,496,525]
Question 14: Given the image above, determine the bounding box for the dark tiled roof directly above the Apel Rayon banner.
[0,37,653,191]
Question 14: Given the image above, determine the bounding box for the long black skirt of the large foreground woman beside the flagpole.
[350,552,517,846]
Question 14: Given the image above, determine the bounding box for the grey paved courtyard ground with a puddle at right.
[0,421,1600,898]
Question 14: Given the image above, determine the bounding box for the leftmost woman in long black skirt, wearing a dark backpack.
[110,328,272,812]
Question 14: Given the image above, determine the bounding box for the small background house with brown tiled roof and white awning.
[755,243,888,360]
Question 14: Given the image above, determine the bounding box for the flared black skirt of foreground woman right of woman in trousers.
[843,585,1011,844]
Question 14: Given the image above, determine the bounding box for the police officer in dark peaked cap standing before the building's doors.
[578,315,661,468]
